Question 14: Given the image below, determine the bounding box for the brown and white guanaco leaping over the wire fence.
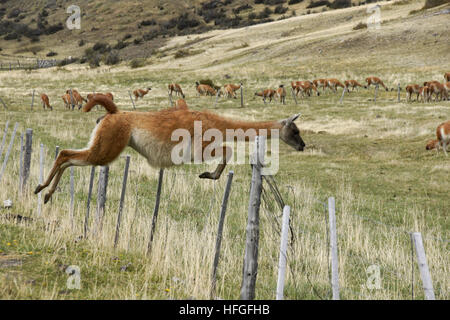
[34,95,305,203]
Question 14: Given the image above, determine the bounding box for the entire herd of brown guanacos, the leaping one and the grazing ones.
[30,73,450,203]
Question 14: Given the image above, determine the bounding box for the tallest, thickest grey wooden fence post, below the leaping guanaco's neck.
[241,136,266,300]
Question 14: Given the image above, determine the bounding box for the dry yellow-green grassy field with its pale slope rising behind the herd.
[0,1,450,299]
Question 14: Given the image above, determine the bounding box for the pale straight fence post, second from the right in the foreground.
[328,197,340,300]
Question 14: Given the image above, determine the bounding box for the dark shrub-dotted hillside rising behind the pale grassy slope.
[0,0,390,62]
